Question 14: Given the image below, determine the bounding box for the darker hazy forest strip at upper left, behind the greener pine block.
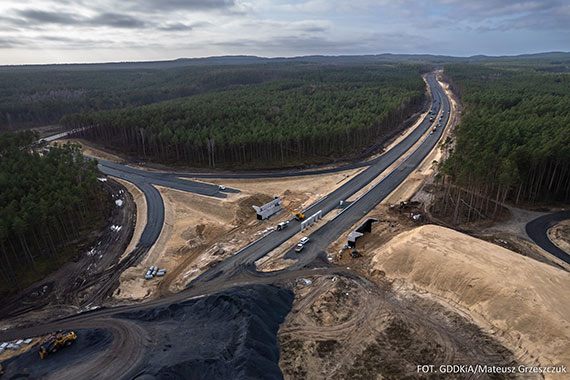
[0,66,290,131]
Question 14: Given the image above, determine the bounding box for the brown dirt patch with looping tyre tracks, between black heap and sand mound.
[279,276,540,379]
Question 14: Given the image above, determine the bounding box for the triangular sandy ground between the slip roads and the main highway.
[114,169,363,301]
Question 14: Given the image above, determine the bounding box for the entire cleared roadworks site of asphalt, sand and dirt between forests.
[0,71,570,380]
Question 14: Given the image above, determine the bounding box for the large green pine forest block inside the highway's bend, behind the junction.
[61,66,425,167]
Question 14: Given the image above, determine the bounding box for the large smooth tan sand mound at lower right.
[371,225,570,372]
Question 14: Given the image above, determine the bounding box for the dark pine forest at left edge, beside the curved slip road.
[0,132,107,291]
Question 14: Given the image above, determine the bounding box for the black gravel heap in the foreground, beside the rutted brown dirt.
[120,285,294,380]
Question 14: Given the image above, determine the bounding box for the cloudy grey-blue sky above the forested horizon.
[0,0,570,64]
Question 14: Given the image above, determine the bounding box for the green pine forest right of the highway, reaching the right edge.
[432,65,570,223]
